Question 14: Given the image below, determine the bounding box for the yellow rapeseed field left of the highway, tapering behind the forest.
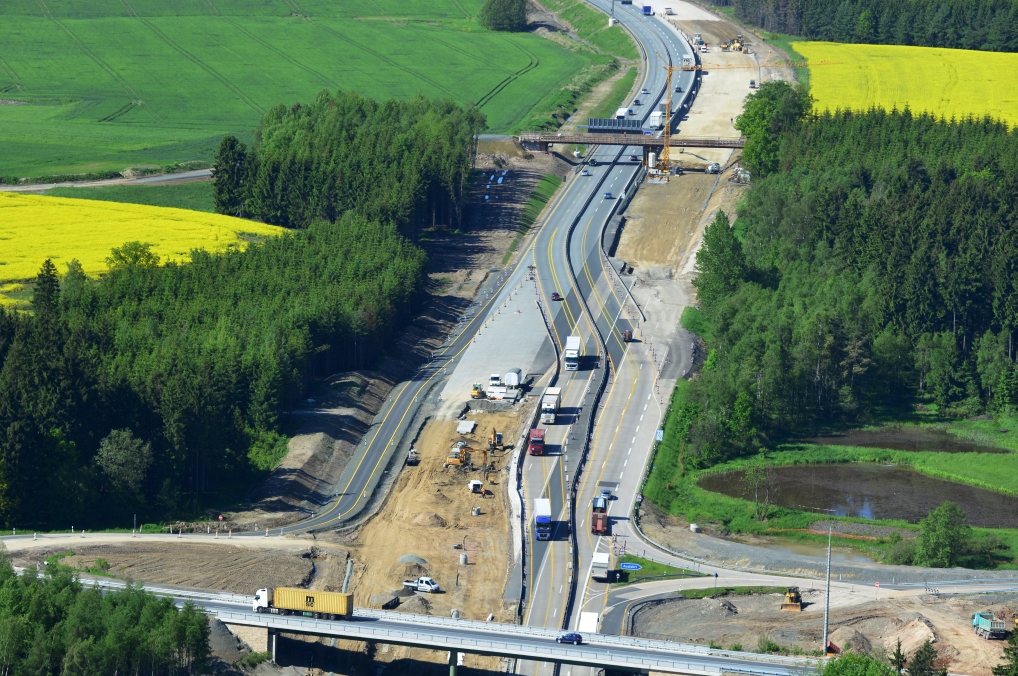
[0,192,284,285]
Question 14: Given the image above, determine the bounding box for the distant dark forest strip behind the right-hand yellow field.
[717,0,1018,52]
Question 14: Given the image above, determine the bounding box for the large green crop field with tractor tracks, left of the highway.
[0,0,594,176]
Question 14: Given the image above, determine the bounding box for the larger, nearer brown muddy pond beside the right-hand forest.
[699,462,1018,528]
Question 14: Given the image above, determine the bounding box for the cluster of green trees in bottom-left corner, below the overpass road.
[0,550,211,676]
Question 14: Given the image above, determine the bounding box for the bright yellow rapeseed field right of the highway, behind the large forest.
[792,42,1018,124]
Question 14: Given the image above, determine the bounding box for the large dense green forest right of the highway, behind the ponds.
[678,82,1018,466]
